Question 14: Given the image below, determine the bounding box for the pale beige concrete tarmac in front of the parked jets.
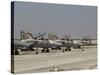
[14,47,97,74]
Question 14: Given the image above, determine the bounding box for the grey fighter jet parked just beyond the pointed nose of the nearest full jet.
[48,33,82,51]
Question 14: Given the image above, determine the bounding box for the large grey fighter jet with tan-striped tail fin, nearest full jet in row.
[11,32,62,53]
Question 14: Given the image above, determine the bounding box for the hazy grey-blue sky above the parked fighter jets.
[11,2,97,38]
